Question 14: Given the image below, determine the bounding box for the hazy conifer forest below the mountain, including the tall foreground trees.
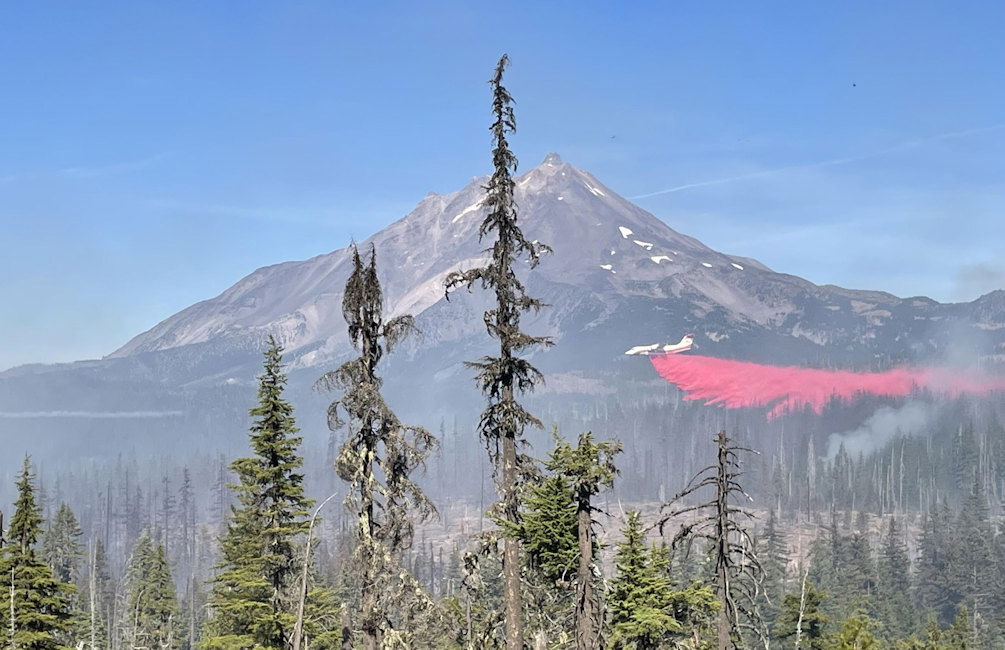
[0,57,1005,650]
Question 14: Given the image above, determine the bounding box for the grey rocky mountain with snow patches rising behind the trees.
[0,154,1005,444]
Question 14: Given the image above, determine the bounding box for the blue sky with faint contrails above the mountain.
[0,0,1005,369]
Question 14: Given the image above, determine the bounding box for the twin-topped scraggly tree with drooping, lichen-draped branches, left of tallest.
[316,246,436,650]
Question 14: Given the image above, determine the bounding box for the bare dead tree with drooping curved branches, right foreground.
[659,430,767,650]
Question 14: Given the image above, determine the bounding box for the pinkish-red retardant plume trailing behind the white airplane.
[649,355,1005,418]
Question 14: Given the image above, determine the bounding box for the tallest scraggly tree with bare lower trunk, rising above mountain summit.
[446,54,551,650]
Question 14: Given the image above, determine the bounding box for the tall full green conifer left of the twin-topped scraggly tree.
[200,337,312,649]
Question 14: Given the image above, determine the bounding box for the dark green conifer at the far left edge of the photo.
[0,456,73,650]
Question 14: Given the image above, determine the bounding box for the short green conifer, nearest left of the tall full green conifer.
[124,532,179,650]
